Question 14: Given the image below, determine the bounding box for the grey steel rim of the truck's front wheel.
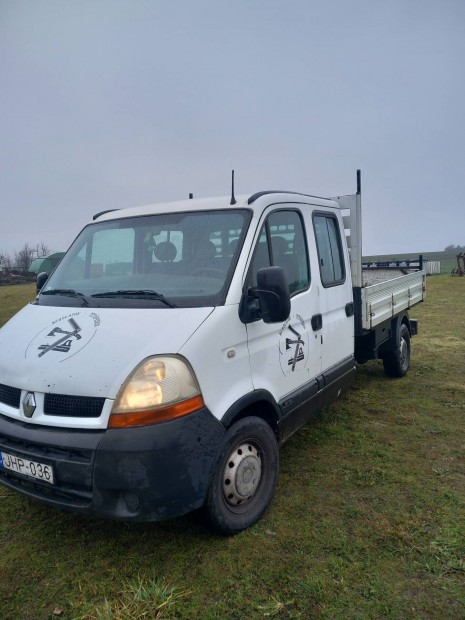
[223,442,262,506]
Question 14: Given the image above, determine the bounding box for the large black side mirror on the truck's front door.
[239,267,291,323]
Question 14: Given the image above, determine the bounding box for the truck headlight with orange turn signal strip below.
[109,356,204,428]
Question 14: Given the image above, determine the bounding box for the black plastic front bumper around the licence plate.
[0,408,225,521]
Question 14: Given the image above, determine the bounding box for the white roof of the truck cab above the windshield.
[93,190,339,222]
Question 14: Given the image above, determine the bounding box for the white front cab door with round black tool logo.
[245,204,321,430]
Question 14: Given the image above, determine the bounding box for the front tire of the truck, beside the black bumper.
[204,417,279,536]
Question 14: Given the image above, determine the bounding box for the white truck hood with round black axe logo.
[0,304,213,398]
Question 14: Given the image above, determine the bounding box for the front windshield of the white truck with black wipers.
[36,209,251,308]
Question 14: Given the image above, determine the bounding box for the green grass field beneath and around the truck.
[0,276,465,620]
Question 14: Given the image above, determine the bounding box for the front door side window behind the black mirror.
[247,210,310,295]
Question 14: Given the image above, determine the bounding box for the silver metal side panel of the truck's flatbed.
[361,271,426,330]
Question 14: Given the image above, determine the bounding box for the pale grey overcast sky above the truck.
[0,0,465,255]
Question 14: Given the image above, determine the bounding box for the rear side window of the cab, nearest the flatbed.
[313,214,346,286]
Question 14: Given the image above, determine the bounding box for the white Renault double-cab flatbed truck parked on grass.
[0,171,425,534]
